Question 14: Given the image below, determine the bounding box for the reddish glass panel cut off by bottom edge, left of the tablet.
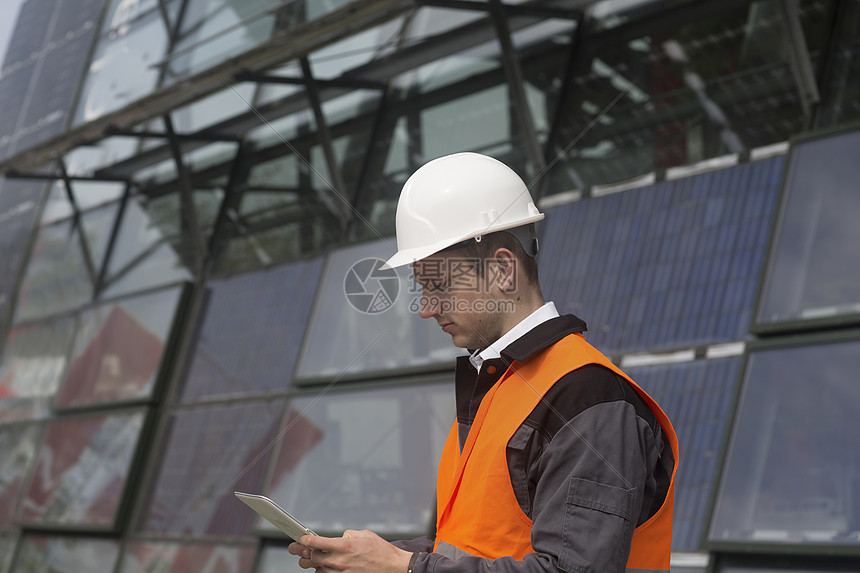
[120,541,256,573]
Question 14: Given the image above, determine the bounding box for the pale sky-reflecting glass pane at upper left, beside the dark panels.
[74,0,182,125]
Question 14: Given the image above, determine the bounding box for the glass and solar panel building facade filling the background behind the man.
[0,0,860,573]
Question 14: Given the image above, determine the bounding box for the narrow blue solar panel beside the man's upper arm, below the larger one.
[625,356,741,551]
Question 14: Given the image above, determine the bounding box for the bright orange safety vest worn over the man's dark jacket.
[436,333,678,571]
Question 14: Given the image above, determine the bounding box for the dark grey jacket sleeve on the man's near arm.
[415,367,662,573]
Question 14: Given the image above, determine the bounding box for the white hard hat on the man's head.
[386,153,544,267]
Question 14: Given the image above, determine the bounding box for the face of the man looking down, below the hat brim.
[412,251,504,348]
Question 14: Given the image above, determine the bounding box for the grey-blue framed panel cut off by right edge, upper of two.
[757,131,860,323]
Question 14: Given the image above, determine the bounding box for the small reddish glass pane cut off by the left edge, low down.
[0,424,39,524]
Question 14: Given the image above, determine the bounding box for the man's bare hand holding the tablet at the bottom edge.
[289,529,412,573]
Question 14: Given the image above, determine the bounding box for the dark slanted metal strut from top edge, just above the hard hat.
[489,0,546,177]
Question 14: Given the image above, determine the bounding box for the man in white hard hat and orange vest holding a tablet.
[290,153,678,573]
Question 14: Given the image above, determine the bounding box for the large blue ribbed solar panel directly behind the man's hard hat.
[540,156,785,353]
